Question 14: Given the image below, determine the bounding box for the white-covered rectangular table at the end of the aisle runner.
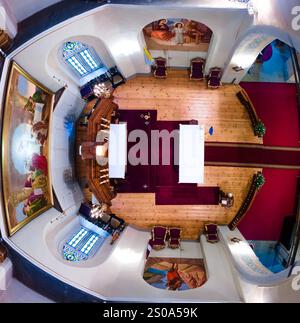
[179,124,204,184]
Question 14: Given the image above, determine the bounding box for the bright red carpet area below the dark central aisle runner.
[238,169,300,241]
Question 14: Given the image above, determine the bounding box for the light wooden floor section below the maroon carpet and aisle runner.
[112,166,261,240]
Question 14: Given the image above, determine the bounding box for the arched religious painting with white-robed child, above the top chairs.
[143,18,213,52]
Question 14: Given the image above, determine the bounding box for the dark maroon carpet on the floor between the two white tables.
[118,114,219,205]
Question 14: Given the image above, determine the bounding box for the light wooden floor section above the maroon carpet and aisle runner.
[114,70,262,144]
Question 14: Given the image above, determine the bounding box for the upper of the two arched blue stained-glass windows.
[63,41,104,77]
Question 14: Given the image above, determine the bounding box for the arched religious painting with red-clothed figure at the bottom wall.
[144,257,207,291]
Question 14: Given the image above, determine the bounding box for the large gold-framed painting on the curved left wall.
[2,62,54,235]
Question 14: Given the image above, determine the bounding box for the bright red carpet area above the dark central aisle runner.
[240,82,300,147]
